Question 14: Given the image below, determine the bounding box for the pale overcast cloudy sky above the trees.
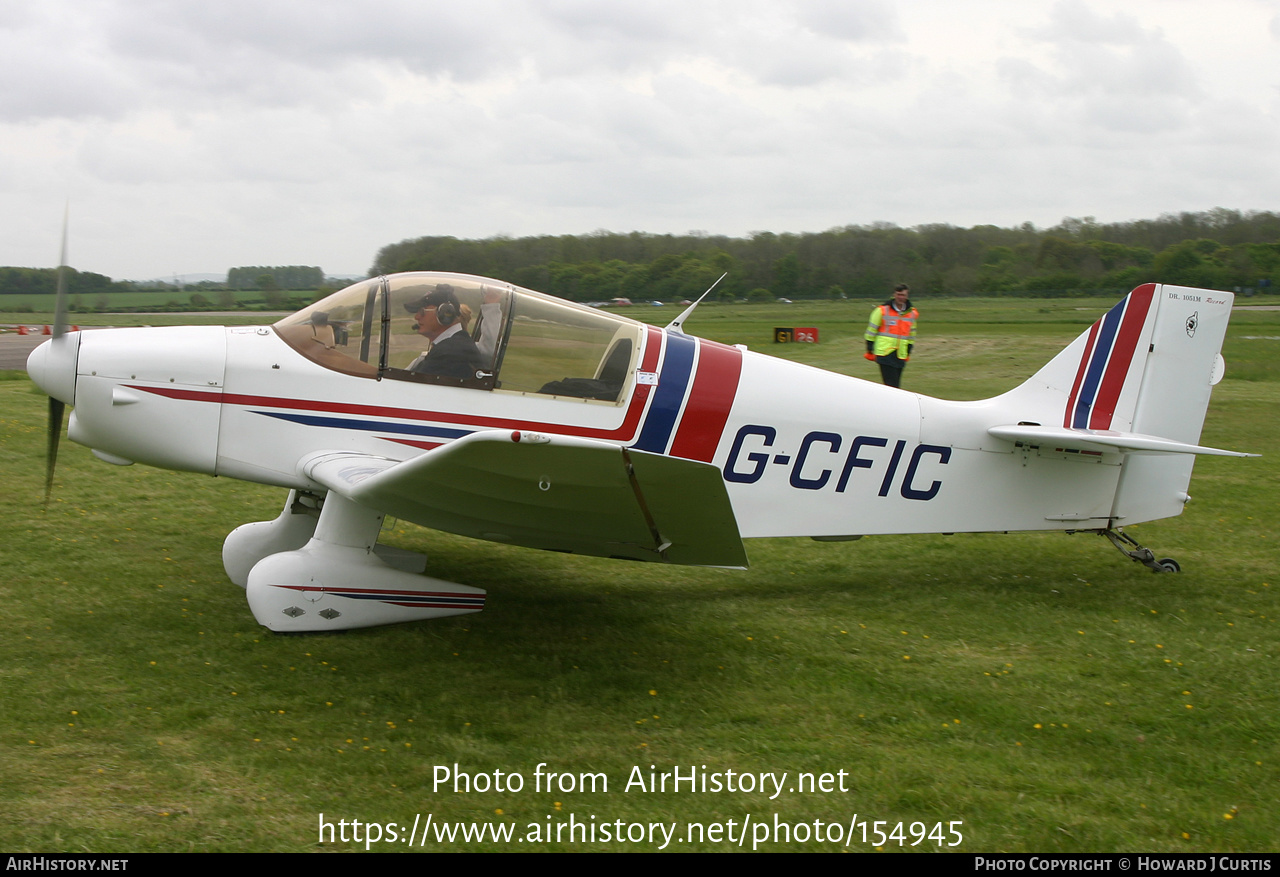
[0,0,1280,279]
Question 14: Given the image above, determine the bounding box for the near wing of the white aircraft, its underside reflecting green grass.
[301,430,746,567]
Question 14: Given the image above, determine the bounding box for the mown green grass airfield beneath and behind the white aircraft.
[0,300,1280,851]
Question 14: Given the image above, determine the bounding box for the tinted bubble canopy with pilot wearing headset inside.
[274,271,643,405]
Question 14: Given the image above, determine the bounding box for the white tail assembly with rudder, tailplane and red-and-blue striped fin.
[988,283,1248,524]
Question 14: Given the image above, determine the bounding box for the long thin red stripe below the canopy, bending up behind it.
[129,326,662,442]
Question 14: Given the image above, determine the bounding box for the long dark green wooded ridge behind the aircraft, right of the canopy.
[370,207,1280,301]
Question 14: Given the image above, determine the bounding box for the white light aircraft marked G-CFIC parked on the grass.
[27,273,1248,632]
